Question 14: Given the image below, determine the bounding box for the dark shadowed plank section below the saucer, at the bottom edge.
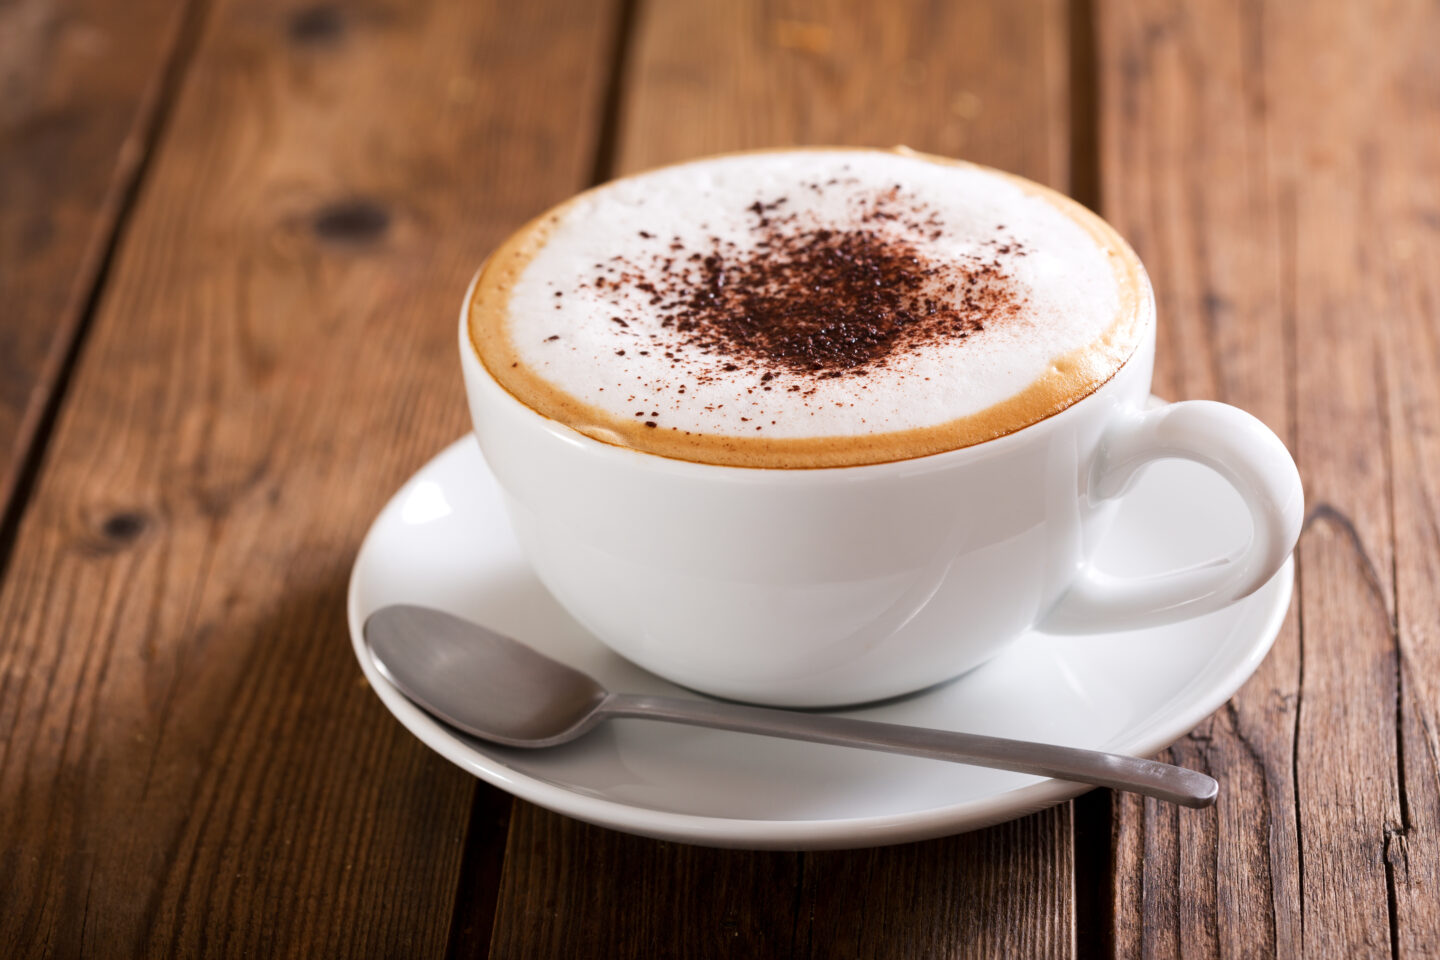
[489,803,1073,960]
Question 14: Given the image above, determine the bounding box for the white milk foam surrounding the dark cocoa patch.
[478,150,1128,460]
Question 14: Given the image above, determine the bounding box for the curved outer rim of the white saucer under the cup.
[346,433,1295,849]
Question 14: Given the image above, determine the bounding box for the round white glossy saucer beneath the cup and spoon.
[348,438,1292,849]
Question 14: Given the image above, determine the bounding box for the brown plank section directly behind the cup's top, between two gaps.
[616,0,1070,190]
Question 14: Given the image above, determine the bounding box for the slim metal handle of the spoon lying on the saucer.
[599,694,1220,807]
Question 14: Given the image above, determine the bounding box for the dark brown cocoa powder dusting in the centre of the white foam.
[581,184,1025,389]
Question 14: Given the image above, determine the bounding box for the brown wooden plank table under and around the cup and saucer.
[0,0,1440,959]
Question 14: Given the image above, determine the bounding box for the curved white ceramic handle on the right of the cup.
[1040,400,1305,633]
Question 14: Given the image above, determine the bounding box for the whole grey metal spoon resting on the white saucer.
[364,606,1220,807]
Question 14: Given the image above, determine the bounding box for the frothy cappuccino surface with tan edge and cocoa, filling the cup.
[468,150,1153,468]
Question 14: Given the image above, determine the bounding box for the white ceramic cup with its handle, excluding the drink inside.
[459,273,1303,707]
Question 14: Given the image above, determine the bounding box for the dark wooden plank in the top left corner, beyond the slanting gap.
[0,0,192,518]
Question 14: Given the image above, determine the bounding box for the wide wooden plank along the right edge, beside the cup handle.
[1097,0,1437,957]
